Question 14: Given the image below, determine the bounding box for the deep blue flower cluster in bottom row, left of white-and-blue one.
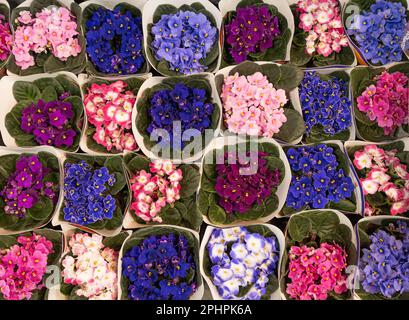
[122,233,197,300]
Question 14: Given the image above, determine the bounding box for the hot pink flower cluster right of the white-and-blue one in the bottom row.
[286,242,347,300]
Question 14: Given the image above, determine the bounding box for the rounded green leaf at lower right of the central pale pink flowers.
[274,108,305,143]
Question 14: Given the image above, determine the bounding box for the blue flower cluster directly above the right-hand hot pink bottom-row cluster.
[286,144,354,210]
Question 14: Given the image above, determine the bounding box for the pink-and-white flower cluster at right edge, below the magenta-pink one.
[353,145,409,216]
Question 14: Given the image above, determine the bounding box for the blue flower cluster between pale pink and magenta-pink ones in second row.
[300,71,352,136]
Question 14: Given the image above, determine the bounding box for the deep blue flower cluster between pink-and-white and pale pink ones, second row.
[147,83,214,149]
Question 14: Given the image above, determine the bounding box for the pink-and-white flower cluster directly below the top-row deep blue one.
[84,80,137,151]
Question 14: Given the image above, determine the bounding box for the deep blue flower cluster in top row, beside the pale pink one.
[85,7,145,74]
